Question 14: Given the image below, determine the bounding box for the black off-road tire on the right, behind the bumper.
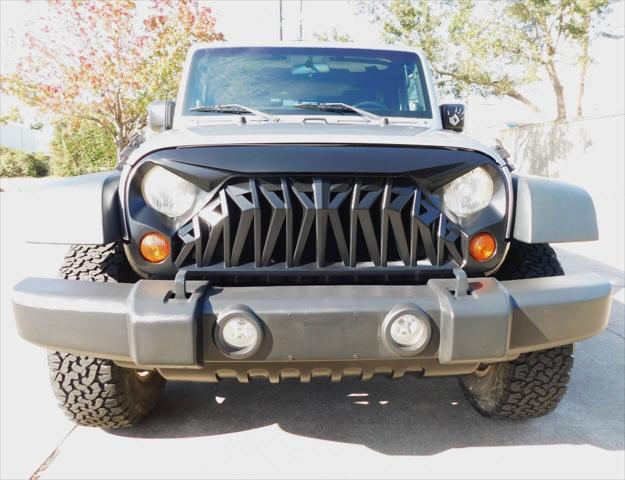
[460,241,573,419]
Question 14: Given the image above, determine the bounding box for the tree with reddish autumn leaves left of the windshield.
[0,0,223,153]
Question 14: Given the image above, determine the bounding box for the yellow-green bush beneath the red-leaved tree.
[50,121,117,176]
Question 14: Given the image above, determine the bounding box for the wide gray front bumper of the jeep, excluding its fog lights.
[13,274,611,379]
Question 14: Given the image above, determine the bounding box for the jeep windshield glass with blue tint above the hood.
[183,47,432,118]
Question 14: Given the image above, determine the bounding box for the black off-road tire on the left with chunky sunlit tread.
[48,243,165,428]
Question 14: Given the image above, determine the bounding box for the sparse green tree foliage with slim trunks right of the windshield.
[360,0,609,119]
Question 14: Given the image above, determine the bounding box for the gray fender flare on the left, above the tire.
[25,170,122,245]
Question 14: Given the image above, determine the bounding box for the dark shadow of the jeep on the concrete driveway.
[110,312,625,455]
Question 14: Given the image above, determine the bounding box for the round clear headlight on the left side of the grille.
[142,166,197,217]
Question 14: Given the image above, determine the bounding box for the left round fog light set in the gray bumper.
[214,306,263,358]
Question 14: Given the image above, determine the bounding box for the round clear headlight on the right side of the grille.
[443,167,493,217]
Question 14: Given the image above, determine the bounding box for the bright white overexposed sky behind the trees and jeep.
[0,0,625,149]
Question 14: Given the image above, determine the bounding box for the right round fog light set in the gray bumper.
[382,304,432,355]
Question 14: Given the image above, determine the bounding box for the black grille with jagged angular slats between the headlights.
[174,178,462,272]
